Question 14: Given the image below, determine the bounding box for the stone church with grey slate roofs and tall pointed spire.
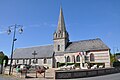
[12,8,110,68]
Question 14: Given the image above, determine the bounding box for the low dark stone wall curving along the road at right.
[55,68,120,79]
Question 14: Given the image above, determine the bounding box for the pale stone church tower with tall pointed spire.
[53,7,69,52]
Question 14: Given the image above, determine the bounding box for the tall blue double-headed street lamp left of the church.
[7,24,23,75]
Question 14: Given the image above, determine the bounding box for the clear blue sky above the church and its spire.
[0,0,120,56]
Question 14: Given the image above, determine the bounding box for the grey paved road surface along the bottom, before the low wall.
[0,73,120,80]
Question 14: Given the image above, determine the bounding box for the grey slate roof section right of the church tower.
[66,38,110,52]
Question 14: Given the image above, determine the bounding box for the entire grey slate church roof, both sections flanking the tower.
[13,38,110,58]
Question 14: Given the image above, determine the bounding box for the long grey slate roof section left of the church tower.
[13,45,53,58]
